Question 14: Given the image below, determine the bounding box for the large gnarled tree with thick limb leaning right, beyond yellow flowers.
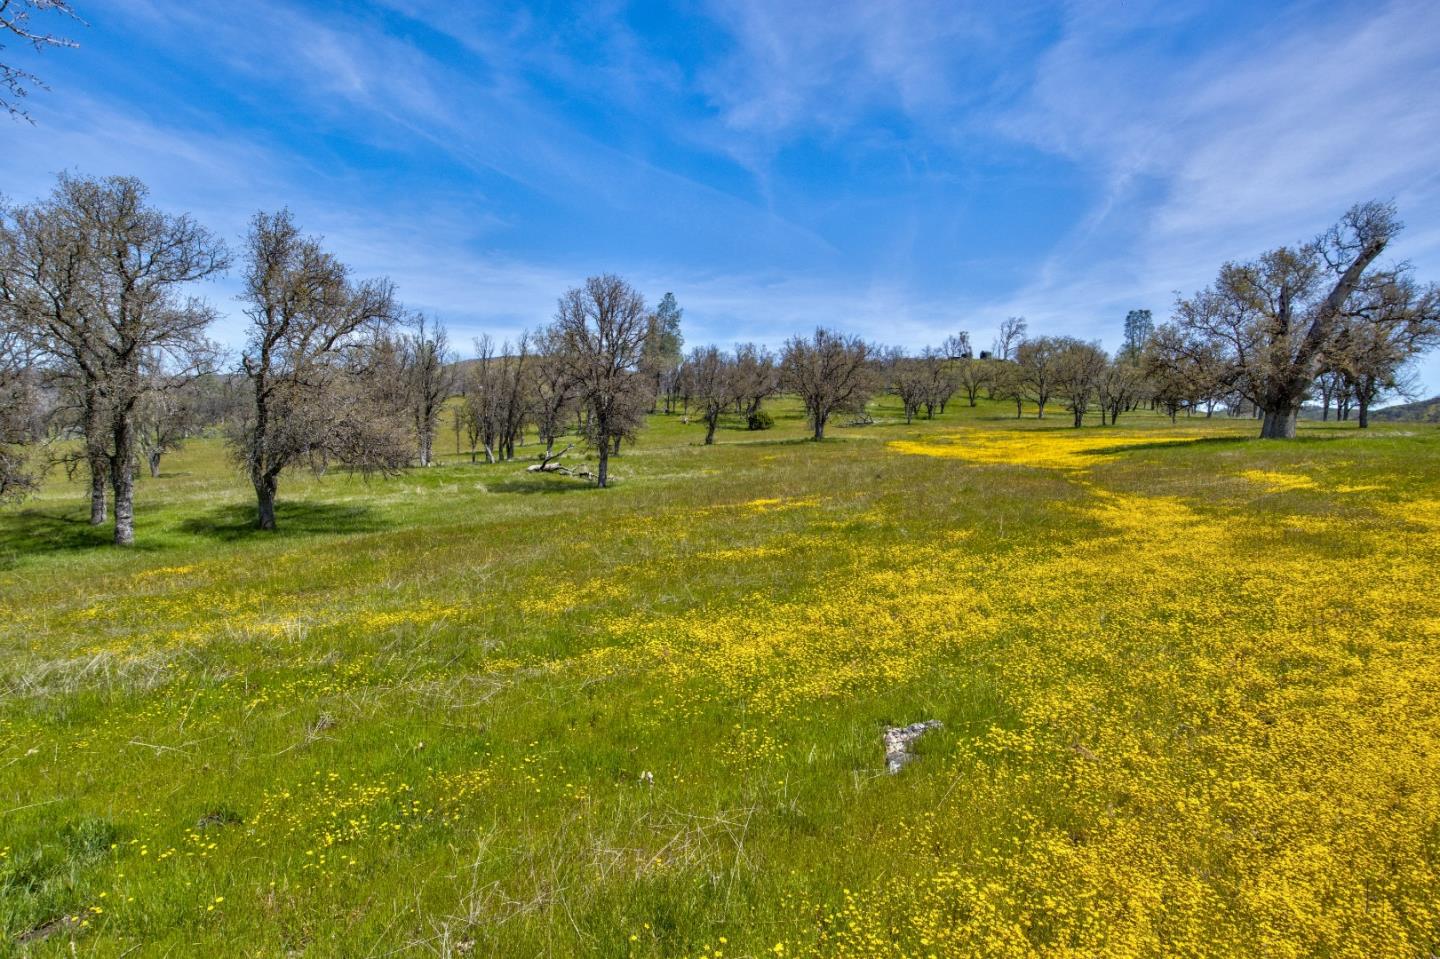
[1175,202,1401,439]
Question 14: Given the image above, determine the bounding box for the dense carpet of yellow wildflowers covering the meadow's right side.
[604,432,1440,959]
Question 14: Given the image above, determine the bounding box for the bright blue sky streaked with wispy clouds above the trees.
[0,0,1440,393]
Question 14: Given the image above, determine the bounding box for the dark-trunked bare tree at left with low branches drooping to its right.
[233,210,412,530]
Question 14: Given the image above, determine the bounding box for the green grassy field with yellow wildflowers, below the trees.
[0,391,1440,958]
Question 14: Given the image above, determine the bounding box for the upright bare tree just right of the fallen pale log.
[554,274,648,488]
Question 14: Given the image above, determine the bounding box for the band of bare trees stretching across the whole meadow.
[0,174,1440,546]
